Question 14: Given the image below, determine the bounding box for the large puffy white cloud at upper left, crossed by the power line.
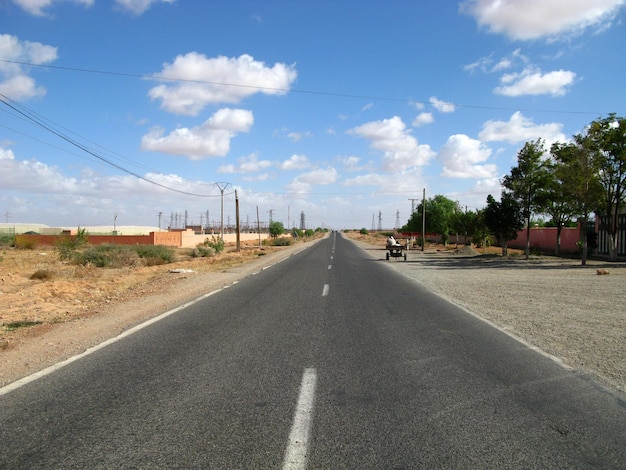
[148,52,297,116]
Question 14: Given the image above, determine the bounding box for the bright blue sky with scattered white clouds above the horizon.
[0,0,626,229]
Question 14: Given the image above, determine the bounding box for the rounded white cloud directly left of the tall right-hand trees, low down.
[439,134,497,178]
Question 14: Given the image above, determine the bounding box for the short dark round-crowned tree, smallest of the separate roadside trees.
[484,191,524,256]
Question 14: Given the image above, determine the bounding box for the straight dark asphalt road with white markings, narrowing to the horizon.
[0,233,626,469]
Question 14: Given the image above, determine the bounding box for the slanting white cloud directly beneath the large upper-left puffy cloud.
[141,108,254,160]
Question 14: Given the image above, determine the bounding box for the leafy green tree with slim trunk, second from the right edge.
[550,134,603,266]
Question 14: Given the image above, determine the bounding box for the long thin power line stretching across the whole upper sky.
[0,59,606,116]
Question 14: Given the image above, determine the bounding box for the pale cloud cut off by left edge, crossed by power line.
[0,34,57,101]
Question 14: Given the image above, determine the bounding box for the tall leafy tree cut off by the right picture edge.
[586,113,626,260]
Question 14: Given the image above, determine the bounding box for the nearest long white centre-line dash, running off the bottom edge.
[283,369,317,470]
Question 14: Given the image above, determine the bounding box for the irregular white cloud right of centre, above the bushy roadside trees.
[348,116,435,172]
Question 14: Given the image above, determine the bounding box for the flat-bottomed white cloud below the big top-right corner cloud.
[494,67,576,96]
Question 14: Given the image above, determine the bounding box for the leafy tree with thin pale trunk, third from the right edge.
[502,139,552,259]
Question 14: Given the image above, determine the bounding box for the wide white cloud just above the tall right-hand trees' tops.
[478,111,566,148]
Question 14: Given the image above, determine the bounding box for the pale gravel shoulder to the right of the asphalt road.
[357,242,626,393]
